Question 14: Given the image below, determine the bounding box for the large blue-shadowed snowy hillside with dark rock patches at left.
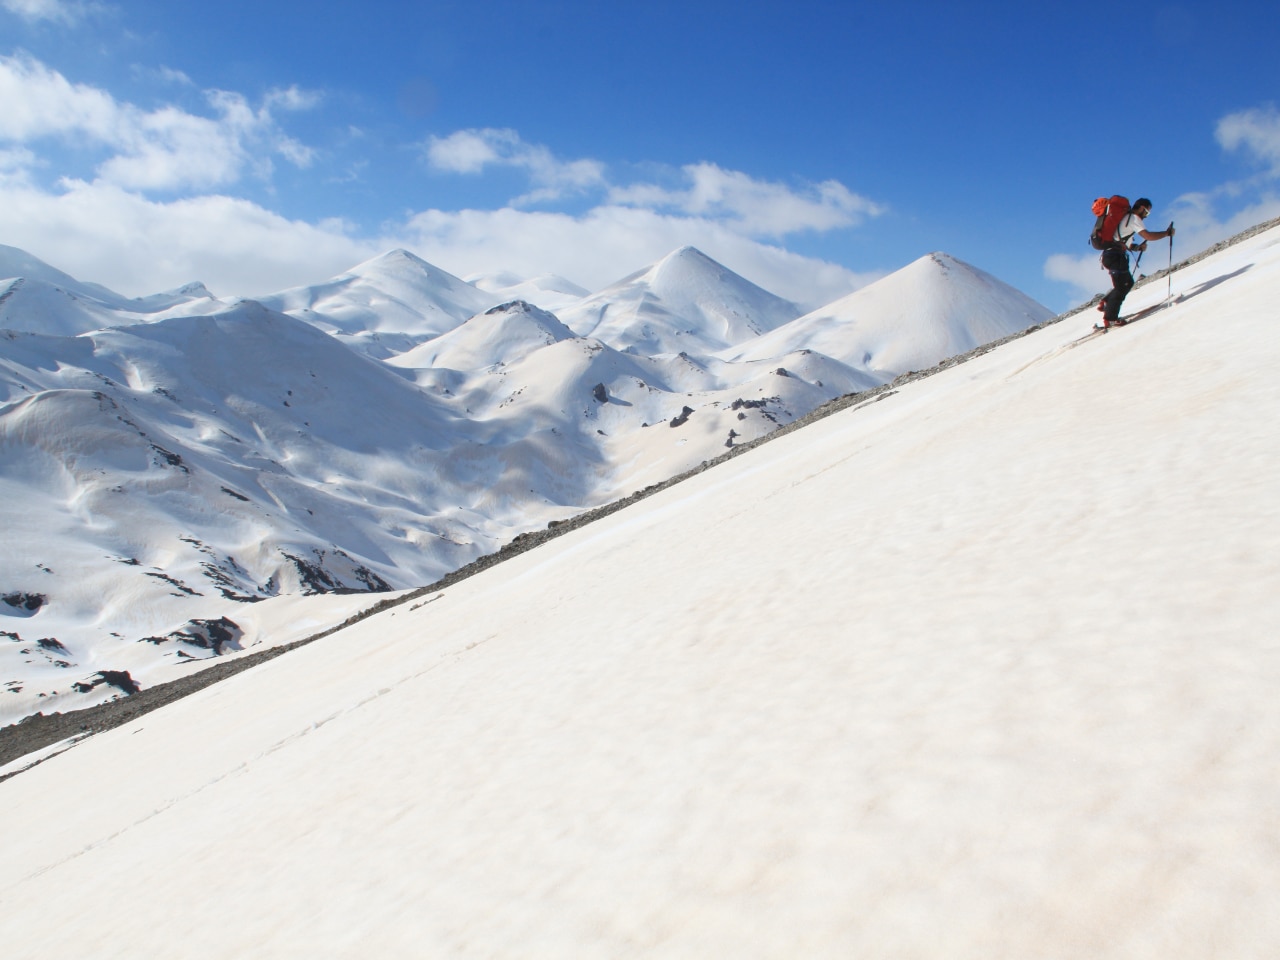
[0,302,582,717]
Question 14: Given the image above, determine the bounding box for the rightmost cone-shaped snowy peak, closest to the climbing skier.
[723,253,1052,381]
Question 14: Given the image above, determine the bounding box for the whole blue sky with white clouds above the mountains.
[0,0,1280,308]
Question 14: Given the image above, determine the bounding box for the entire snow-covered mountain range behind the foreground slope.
[0,246,1050,723]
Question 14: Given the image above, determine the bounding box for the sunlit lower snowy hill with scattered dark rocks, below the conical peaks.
[387,301,878,506]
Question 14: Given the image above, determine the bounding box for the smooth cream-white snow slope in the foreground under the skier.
[0,229,1280,960]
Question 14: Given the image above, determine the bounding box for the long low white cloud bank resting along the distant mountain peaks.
[0,175,877,307]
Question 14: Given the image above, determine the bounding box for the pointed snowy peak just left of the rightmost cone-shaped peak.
[561,247,800,356]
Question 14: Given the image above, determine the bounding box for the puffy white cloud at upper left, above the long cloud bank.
[0,56,316,189]
